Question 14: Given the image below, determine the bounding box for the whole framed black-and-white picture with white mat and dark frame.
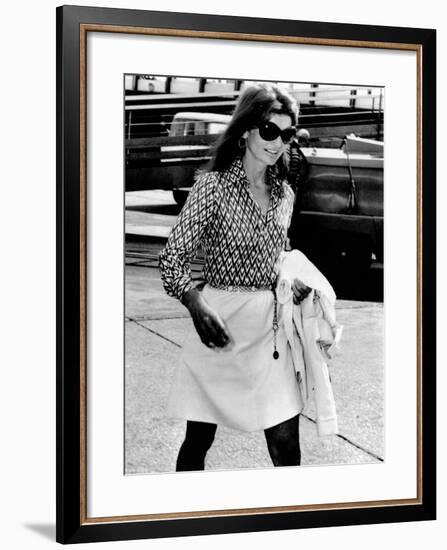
[57,6,436,543]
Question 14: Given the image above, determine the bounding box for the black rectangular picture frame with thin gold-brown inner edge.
[56,6,436,543]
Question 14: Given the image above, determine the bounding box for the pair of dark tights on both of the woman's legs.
[176,415,301,472]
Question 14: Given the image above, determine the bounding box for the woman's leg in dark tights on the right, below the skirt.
[264,415,301,466]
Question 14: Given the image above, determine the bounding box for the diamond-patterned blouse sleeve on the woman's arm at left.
[159,172,217,300]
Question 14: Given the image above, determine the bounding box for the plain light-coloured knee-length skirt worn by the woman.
[167,285,303,432]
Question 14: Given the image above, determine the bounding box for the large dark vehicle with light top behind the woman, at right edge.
[289,136,383,272]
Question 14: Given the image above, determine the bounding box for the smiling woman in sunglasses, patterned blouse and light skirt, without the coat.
[160,85,310,471]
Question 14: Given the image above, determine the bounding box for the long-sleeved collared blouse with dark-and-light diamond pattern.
[159,158,294,299]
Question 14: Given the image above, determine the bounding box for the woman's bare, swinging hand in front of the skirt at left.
[182,288,231,348]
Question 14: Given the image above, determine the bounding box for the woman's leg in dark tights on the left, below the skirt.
[176,420,217,472]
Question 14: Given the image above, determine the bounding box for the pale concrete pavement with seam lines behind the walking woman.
[125,193,385,474]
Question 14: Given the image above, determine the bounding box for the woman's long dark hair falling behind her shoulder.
[206,84,298,177]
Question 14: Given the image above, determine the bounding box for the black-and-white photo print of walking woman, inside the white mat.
[124,75,385,474]
